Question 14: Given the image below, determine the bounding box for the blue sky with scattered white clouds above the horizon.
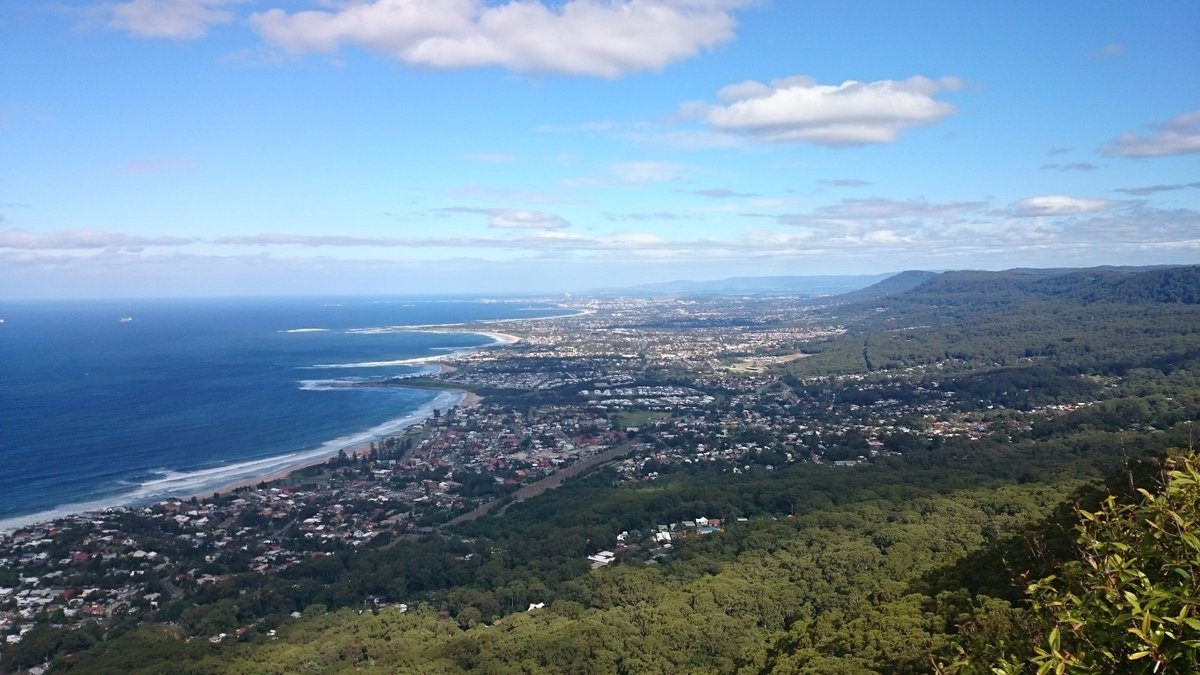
[0,0,1200,298]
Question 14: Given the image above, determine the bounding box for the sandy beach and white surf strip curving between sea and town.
[0,324,523,533]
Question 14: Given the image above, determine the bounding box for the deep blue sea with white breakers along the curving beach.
[0,298,564,530]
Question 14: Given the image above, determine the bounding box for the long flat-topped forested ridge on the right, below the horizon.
[792,265,1200,379]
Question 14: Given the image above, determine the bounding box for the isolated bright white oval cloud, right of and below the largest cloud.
[696,76,962,145]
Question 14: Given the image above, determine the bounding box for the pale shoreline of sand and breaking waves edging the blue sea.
[0,315,528,534]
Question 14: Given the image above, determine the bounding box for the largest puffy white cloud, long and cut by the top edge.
[251,0,745,78]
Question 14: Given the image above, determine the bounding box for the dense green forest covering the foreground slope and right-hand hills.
[11,267,1200,674]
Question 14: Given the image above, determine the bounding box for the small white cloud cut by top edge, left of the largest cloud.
[108,0,240,40]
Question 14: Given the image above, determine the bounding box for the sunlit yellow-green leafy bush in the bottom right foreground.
[1003,453,1200,674]
